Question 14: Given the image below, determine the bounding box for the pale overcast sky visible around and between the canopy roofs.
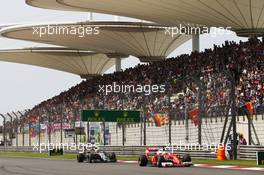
[0,0,246,121]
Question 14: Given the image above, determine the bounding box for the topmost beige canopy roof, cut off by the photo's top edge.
[26,0,264,35]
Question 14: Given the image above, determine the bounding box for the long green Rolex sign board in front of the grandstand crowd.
[82,110,140,123]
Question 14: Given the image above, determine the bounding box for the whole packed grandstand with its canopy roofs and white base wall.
[0,0,264,163]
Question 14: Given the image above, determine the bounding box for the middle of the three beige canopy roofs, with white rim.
[0,22,191,61]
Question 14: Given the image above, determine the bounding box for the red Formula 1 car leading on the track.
[138,147,193,167]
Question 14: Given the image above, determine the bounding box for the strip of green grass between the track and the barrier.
[0,152,264,168]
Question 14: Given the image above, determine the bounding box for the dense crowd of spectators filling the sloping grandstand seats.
[10,38,264,129]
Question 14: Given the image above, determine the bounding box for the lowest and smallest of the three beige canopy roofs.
[0,48,120,78]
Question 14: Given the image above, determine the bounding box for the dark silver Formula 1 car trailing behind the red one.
[77,146,117,163]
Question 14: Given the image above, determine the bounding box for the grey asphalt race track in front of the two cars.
[0,157,263,175]
